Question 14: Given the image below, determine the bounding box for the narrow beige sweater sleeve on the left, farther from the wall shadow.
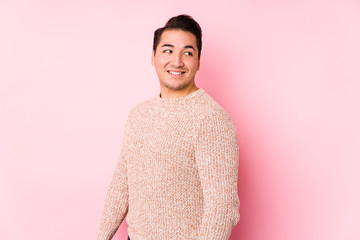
[97,117,129,240]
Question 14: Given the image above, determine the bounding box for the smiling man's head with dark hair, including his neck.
[151,15,201,98]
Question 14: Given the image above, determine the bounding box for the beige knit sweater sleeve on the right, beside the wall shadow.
[195,113,240,240]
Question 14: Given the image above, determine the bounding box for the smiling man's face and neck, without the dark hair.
[151,29,200,93]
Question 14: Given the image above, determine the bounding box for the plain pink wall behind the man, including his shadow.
[0,0,360,240]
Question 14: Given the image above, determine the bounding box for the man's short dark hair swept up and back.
[153,14,202,58]
